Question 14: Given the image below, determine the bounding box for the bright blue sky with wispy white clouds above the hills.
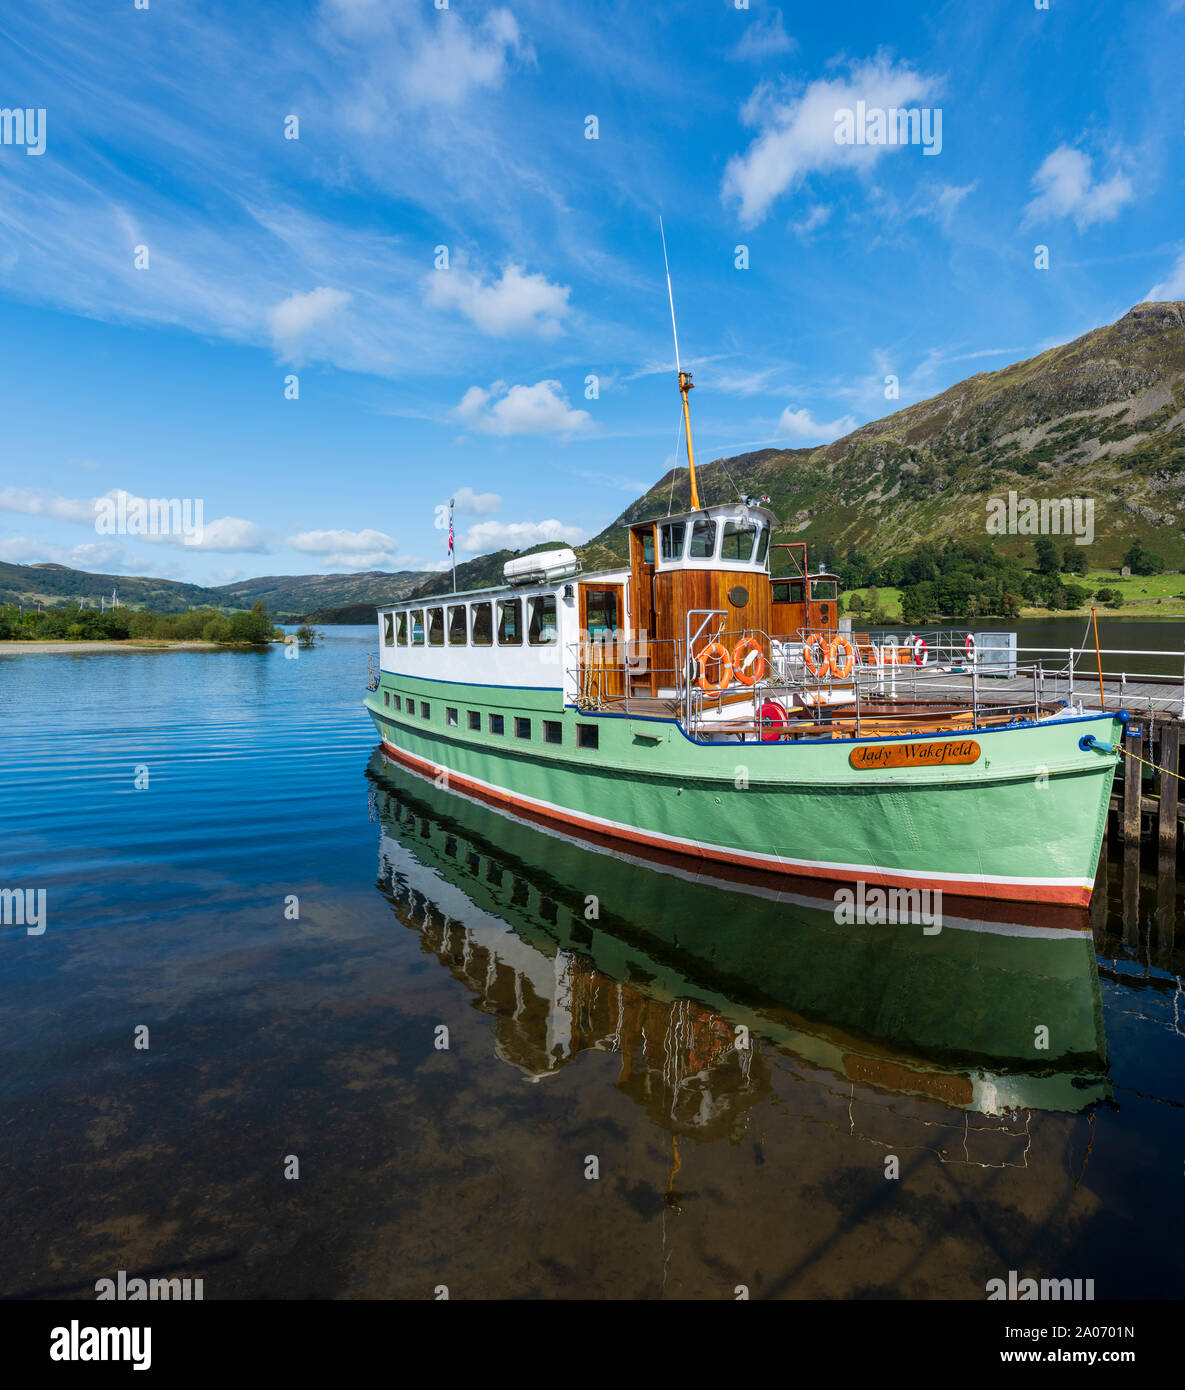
[0,0,1185,584]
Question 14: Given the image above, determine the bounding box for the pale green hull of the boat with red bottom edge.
[367,673,1121,906]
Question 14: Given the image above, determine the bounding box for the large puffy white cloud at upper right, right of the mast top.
[721,54,940,227]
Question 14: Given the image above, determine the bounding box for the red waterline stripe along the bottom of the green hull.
[382,738,1092,908]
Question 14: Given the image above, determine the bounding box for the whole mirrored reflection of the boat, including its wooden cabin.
[370,752,1110,1150]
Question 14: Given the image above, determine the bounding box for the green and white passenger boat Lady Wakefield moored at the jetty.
[364,290,1127,910]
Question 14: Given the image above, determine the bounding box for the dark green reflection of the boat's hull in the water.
[371,755,1109,1113]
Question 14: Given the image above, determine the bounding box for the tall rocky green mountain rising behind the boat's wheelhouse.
[589,303,1185,569]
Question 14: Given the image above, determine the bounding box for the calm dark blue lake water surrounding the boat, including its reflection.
[0,624,1185,1298]
